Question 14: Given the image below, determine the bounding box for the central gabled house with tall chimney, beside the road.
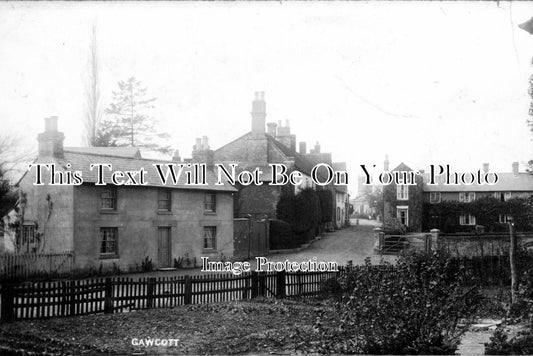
[214,92,347,228]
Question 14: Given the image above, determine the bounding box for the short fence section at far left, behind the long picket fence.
[0,251,74,280]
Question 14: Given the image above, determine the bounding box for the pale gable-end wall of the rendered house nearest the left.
[18,160,74,253]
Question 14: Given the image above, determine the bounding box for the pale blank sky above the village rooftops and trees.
[0,2,533,193]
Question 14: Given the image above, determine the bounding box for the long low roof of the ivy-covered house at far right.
[423,172,533,192]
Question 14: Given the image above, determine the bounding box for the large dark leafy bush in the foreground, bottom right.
[325,252,481,354]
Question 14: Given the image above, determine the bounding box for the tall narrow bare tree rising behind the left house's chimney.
[84,23,102,146]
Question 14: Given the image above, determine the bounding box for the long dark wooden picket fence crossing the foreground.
[0,272,338,321]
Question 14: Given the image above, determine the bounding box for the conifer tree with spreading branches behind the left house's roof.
[95,77,171,153]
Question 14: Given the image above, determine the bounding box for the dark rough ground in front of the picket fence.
[0,300,337,355]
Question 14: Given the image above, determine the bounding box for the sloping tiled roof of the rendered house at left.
[58,151,236,192]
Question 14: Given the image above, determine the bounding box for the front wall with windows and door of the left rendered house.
[74,184,233,270]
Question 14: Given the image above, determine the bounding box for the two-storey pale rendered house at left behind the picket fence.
[7,117,236,270]
